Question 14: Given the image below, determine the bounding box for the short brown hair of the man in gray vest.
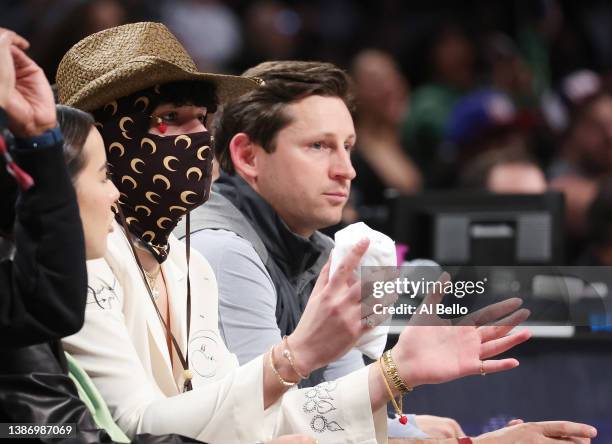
[215,61,354,174]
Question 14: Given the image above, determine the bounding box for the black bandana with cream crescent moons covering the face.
[94,88,213,263]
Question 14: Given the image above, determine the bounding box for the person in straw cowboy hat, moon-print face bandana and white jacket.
[57,23,588,443]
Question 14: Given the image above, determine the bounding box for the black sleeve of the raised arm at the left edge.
[0,140,87,349]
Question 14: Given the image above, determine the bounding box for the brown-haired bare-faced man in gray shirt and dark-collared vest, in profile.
[176,62,463,438]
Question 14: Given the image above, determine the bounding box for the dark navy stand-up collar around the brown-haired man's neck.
[213,172,326,277]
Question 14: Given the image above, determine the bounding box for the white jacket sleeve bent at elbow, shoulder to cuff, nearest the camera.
[64,261,265,443]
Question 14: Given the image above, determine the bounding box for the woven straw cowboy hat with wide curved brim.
[56,22,262,111]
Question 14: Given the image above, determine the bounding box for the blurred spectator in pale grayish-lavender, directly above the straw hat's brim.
[161,0,242,71]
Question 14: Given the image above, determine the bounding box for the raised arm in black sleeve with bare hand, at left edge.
[0,28,87,347]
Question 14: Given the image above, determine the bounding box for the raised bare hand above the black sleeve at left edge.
[0,28,57,137]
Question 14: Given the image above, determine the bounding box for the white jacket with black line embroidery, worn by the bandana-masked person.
[64,223,387,443]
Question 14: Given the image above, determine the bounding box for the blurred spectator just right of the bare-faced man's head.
[351,49,422,227]
